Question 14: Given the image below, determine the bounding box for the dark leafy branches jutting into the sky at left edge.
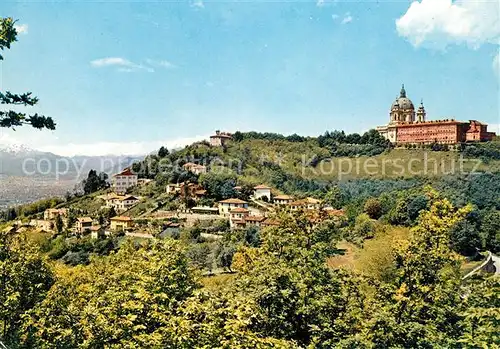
[0,17,56,130]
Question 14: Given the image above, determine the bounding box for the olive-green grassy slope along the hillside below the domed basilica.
[219,140,500,182]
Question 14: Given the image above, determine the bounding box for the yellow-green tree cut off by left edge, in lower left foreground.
[0,234,54,347]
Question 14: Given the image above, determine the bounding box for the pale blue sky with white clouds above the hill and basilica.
[0,0,500,155]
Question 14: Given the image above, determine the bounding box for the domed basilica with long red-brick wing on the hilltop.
[377,85,495,144]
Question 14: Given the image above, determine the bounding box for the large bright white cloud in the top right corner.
[396,0,500,48]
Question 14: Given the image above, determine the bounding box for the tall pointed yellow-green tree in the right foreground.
[366,196,471,348]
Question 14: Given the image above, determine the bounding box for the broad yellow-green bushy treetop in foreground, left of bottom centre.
[23,239,198,349]
